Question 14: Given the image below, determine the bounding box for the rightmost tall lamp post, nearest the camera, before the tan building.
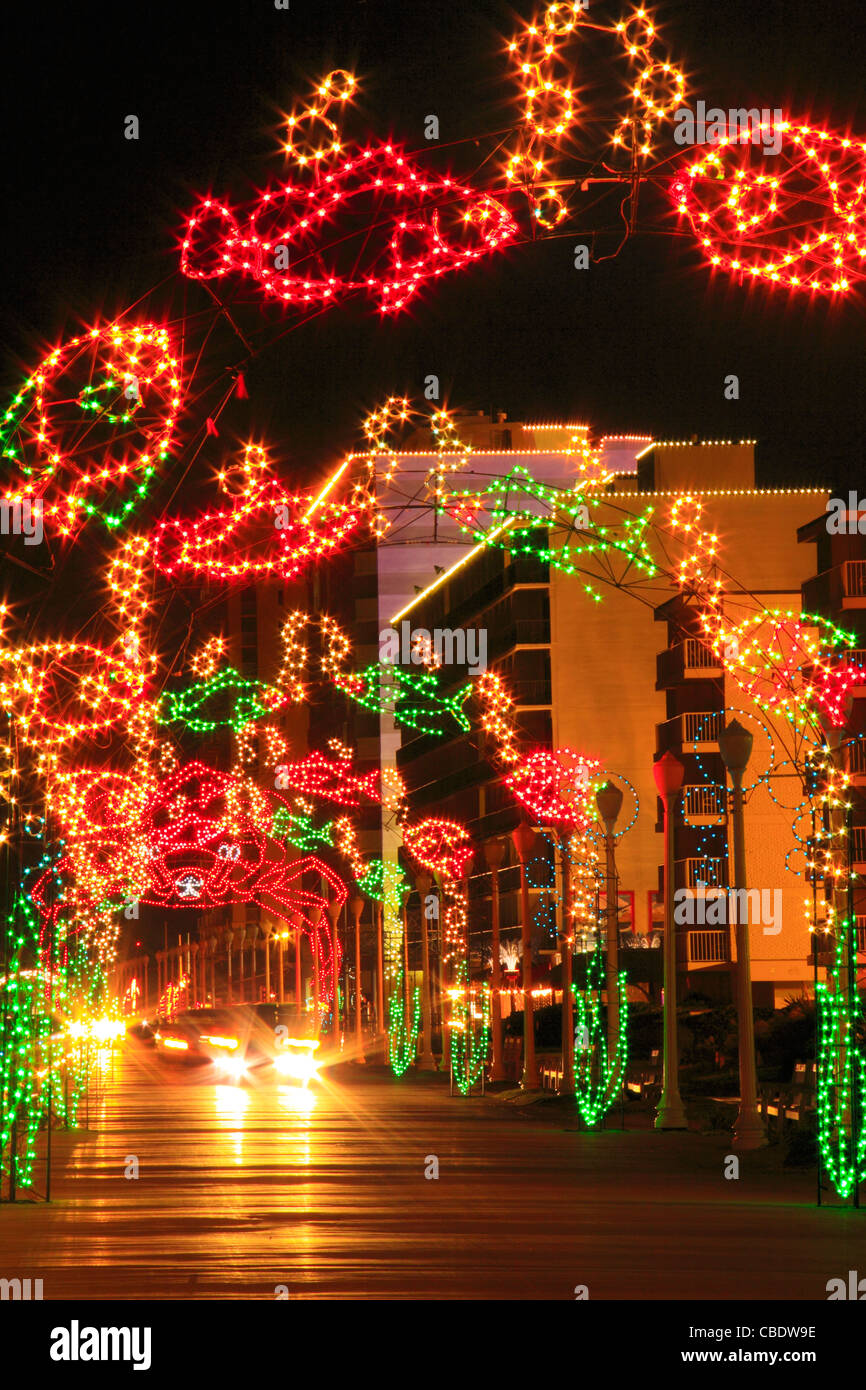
[719,719,767,1148]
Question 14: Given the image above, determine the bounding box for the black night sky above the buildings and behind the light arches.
[0,0,866,506]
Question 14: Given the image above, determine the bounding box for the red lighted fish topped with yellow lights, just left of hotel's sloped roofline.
[153,445,374,582]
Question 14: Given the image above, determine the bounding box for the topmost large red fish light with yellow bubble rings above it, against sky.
[181,74,517,314]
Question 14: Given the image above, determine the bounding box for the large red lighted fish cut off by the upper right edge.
[671,118,866,295]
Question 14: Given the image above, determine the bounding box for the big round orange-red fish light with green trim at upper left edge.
[0,324,182,537]
